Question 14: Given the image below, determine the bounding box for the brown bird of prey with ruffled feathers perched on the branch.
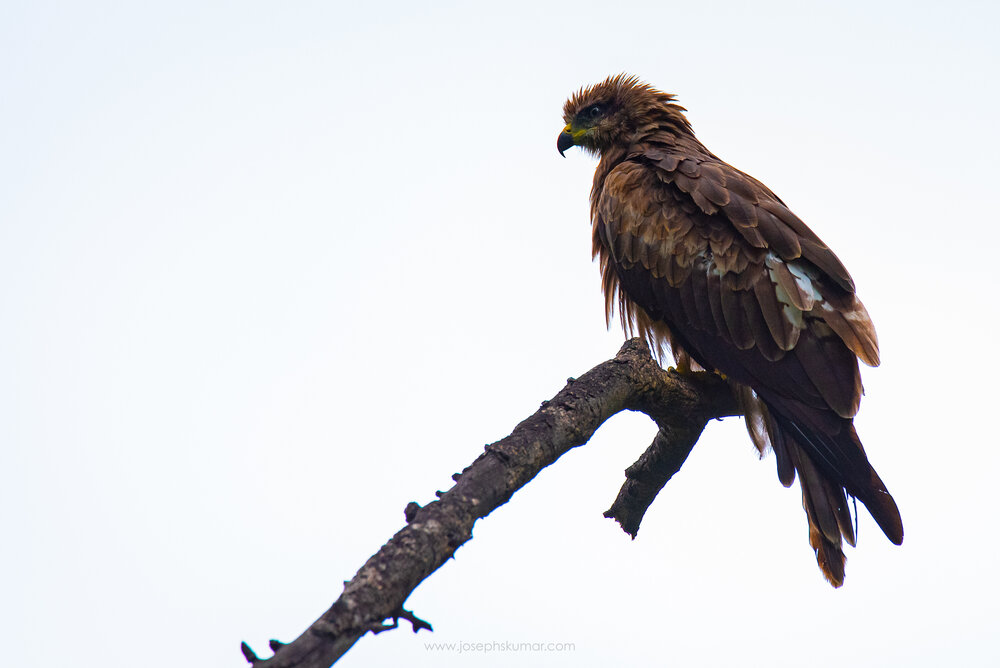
[557,74,903,587]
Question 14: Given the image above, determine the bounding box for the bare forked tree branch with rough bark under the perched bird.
[242,339,736,668]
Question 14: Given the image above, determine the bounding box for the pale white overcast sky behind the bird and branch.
[0,0,1000,668]
